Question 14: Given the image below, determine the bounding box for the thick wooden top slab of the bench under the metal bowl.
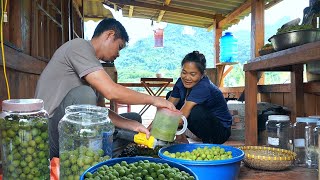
[243,41,320,71]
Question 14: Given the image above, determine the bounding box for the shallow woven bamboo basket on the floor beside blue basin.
[239,146,296,171]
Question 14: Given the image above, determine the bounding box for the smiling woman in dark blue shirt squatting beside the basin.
[168,51,232,144]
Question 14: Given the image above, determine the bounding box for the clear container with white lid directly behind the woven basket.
[266,115,292,150]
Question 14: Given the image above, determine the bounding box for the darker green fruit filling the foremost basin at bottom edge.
[85,160,195,180]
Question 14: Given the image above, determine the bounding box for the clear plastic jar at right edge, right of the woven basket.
[293,117,318,167]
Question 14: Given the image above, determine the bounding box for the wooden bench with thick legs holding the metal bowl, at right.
[243,42,320,145]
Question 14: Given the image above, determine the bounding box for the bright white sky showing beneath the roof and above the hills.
[84,0,309,45]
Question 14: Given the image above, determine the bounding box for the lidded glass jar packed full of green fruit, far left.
[0,99,50,180]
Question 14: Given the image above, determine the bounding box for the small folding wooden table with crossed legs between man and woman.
[139,78,173,115]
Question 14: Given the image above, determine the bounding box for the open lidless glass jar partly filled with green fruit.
[58,105,114,180]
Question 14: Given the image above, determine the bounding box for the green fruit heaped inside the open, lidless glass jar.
[60,146,110,180]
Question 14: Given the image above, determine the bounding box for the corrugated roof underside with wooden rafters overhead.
[84,0,282,29]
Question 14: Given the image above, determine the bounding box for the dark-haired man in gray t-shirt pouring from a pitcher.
[35,19,175,158]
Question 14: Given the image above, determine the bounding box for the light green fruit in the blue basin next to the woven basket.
[163,146,232,161]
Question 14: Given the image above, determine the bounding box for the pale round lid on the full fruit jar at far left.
[2,99,43,112]
